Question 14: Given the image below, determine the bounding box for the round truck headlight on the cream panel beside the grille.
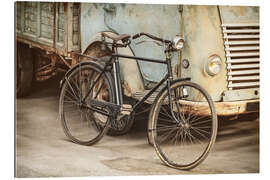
[205,55,221,76]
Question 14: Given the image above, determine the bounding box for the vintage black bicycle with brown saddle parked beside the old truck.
[59,32,217,170]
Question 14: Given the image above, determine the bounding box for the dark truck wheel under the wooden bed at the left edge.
[16,43,33,97]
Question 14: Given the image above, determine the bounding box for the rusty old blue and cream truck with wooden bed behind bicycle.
[15,2,260,133]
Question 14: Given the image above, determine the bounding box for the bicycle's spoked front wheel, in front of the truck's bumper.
[150,81,217,170]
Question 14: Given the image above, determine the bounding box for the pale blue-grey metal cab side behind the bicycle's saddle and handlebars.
[81,3,181,82]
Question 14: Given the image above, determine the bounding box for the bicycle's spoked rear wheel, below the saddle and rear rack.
[59,63,114,145]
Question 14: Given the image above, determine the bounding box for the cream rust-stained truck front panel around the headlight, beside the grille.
[181,5,227,101]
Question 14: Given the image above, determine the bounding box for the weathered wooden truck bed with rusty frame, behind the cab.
[15,2,80,56]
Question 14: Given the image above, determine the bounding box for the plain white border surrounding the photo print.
[0,0,270,180]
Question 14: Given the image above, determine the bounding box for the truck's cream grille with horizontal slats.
[222,24,260,90]
